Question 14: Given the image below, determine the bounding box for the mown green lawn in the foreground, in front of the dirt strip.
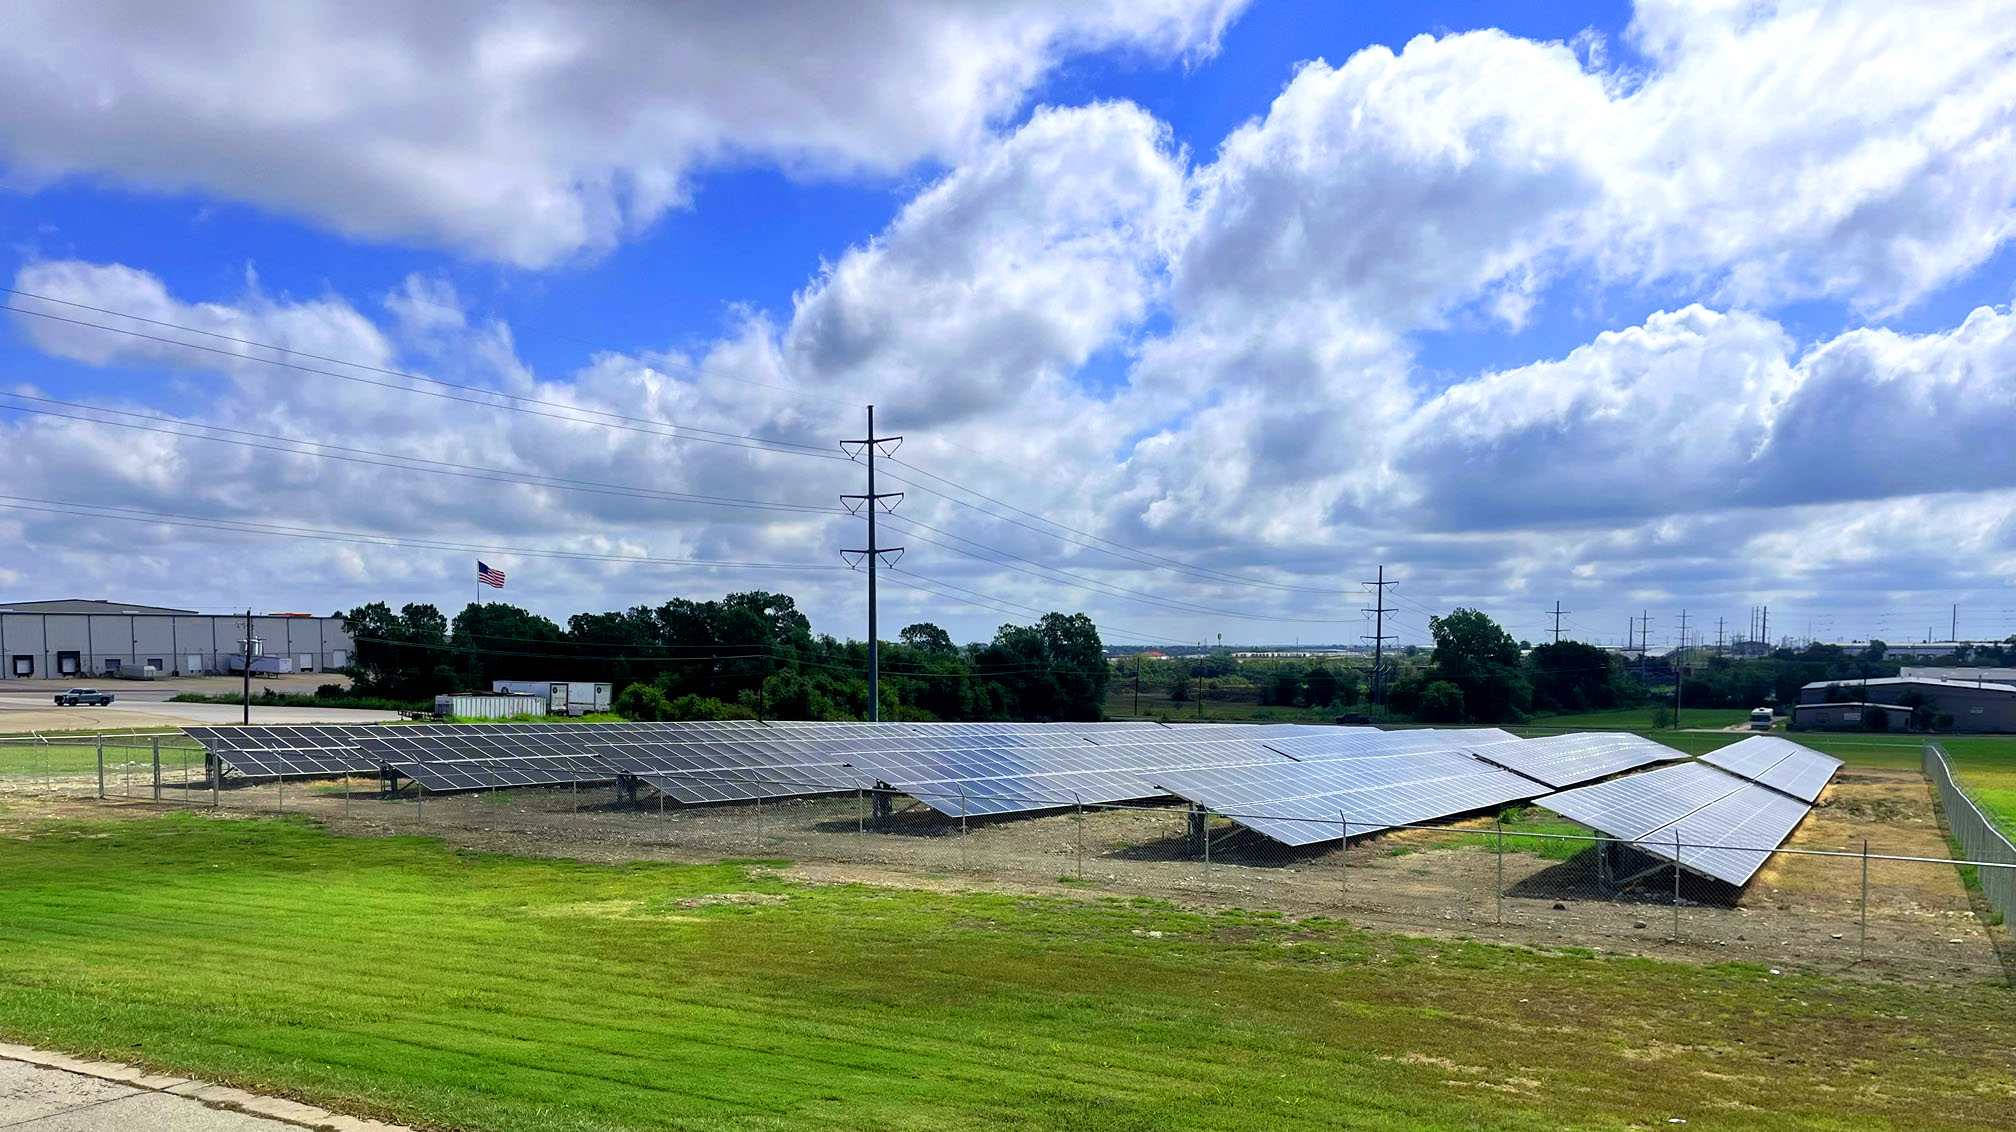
[0,814,2016,1132]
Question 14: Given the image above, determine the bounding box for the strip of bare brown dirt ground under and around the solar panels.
[0,753,2010,981]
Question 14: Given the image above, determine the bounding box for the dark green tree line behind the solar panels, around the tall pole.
[339,590,1111,721]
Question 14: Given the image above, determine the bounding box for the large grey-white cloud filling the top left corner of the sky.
[0,0,1240,266]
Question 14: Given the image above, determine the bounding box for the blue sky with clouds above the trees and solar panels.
[0,0,2016,641]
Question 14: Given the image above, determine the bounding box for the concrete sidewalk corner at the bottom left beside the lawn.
[0,1041,409,1132]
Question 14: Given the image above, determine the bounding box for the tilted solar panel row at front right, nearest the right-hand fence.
[1538,761,1812,886]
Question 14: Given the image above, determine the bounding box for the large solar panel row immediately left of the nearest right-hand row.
[1155,749,1536,846]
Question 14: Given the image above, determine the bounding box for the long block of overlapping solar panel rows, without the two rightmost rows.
[187,719,1749,844]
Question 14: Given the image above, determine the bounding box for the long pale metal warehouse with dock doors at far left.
[0,598,357,681]
